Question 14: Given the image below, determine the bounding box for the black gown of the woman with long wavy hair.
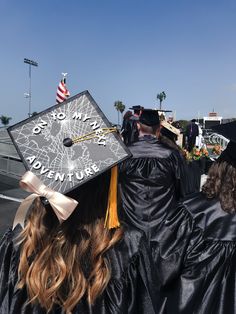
[0,225,157,314]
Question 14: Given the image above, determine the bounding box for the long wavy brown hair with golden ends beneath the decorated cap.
[18,175,122,313]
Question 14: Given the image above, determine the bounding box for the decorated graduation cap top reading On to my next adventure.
[8,91,130,194]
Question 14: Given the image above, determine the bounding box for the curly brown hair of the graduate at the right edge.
[202,161,236,213]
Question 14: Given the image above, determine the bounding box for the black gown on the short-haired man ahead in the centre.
[119,135,185,241]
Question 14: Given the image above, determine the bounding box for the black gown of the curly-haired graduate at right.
[153,193,236,314]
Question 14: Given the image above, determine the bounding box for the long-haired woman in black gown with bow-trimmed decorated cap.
[0,92,157,314]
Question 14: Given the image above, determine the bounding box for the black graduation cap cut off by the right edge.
[212,121,236,167]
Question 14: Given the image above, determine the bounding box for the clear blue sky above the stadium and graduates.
[0,0,236,123]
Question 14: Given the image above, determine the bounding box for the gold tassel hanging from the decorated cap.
[104,166,120,229]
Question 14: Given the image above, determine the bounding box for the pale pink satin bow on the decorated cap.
[13,171,78,229]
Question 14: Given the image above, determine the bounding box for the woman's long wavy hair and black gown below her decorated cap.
[0,171,158,314]
